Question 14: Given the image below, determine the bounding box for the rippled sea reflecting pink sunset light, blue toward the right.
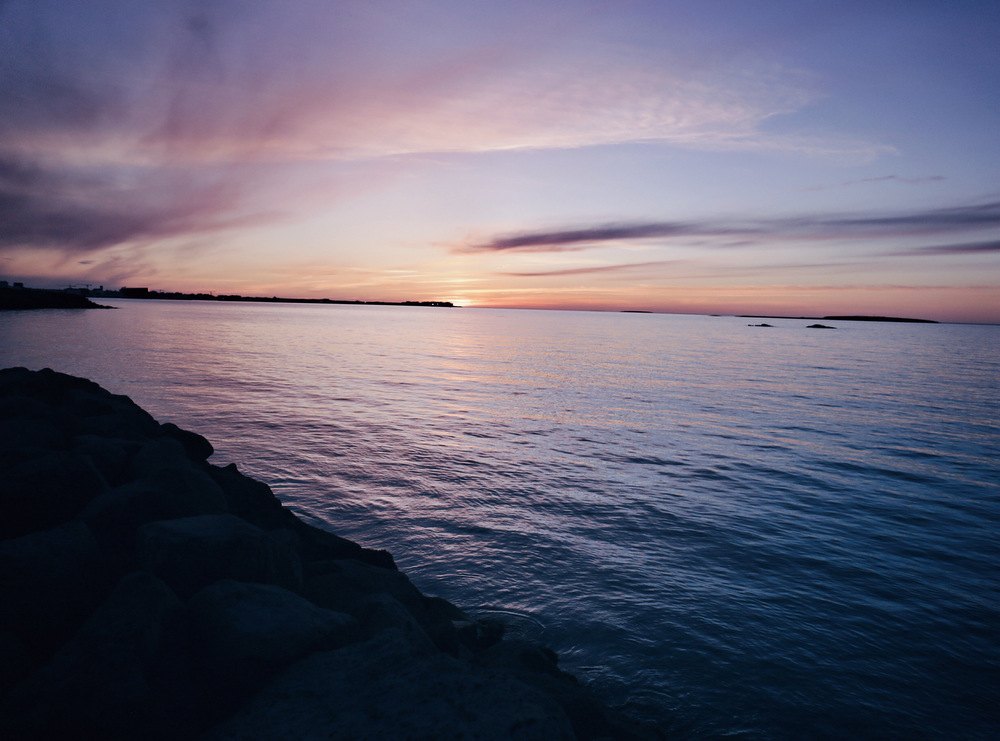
[0,301,1000,741]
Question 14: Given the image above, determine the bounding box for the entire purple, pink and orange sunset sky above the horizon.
[0,0,1000,322]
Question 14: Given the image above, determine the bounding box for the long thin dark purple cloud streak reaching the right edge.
[454,201,1000,253]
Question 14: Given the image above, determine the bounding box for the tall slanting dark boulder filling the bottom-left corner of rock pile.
[0,572,180,739]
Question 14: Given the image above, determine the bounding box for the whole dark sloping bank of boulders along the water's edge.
[0,368,665,741]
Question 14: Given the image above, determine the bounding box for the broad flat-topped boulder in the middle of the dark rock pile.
[138,514,302,599]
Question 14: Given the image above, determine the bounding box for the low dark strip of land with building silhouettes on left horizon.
[0,281,454,310]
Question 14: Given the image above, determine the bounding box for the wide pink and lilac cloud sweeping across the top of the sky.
[0,0,891,161]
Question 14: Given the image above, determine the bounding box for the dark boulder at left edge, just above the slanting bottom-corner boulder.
[0,522,110,657]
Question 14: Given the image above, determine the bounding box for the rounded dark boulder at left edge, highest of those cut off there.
[0,451,108,538]
